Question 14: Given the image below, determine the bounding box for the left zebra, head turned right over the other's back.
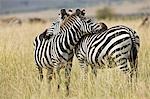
[34,9,99,95]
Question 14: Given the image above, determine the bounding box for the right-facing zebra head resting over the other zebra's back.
[61,9,102,35]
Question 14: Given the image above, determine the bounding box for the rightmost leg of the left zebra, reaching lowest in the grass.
[65,59,72,96]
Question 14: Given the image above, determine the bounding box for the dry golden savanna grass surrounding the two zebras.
[0,19,150,99]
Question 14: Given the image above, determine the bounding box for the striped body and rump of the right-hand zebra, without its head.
[75,25,140,84]
